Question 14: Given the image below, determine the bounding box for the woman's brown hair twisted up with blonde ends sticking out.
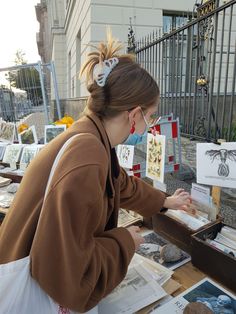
[80,32,160,117]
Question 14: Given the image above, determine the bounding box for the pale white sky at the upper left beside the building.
[0,0,40,68]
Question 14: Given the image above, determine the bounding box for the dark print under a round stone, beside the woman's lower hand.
[137,231,191,270]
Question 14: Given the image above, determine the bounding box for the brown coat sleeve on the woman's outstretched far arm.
[120,168,166,217]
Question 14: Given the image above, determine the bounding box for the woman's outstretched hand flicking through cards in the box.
[164,189,194,214]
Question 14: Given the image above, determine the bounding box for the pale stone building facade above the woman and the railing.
[36,0,196,99]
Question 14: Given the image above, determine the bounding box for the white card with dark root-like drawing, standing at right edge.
[197,142,236,188]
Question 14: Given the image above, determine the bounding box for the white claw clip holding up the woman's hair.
[93,57,119,87]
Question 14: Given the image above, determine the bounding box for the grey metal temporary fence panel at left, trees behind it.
[0,62,61,136]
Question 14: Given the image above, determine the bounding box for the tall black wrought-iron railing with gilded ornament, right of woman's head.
[135,0,236,141]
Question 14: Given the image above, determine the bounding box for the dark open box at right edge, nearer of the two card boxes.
[191,221,236,293]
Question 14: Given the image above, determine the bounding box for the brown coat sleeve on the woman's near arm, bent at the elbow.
[30,165,135,312]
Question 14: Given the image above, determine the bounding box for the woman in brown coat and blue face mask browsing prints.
[0,36,192,312]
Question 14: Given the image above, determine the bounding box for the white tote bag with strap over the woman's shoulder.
[0,134,98,314]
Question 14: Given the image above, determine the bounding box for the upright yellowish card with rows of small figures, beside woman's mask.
[146,133,166,183]
